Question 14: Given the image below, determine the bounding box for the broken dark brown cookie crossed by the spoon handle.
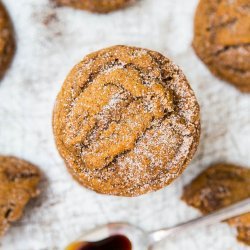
[182,163,250,245]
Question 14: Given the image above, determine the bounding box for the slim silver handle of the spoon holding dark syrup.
[149,198,250,245]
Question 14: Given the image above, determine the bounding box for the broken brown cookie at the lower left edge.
[0,156,41,236]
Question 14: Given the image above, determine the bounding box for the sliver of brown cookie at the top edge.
[53,0,134,13]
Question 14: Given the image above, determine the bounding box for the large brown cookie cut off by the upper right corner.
[193,0,250,92]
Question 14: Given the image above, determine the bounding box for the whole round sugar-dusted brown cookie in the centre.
[53,46,200,196]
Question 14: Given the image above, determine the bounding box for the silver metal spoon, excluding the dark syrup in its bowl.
[66,198,250,250]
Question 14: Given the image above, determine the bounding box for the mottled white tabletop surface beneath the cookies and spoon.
[0,0,250,250]
